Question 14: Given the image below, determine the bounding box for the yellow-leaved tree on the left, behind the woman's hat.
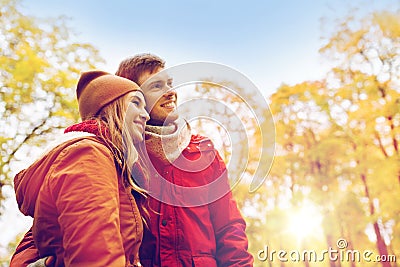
[0,0,103,209]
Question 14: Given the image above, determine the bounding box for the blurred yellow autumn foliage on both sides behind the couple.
[0,0,400,267]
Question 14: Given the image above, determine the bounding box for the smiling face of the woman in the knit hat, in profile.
[125,91,150,143]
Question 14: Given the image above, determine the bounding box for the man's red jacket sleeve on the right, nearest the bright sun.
[209,152,254,267]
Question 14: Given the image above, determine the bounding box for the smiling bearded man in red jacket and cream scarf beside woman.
[10,54,253,267]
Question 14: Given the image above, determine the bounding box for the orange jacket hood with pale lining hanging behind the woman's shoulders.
[14,132,94,217]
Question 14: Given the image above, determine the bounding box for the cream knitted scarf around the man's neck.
[145,119,191,164]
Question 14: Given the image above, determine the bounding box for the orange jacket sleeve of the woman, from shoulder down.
[48,140,126,267]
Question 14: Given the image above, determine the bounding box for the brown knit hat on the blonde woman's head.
[76,70,141,120]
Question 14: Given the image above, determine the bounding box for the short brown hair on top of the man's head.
[115,53,165,85]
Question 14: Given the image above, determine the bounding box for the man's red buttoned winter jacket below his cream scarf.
[140,136,253,267]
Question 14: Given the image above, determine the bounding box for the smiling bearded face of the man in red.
[139,68,179,126]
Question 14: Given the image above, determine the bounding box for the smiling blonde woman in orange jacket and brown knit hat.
[10,71,149,267]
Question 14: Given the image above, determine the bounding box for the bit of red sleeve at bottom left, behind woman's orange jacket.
[10,229,39,267]
